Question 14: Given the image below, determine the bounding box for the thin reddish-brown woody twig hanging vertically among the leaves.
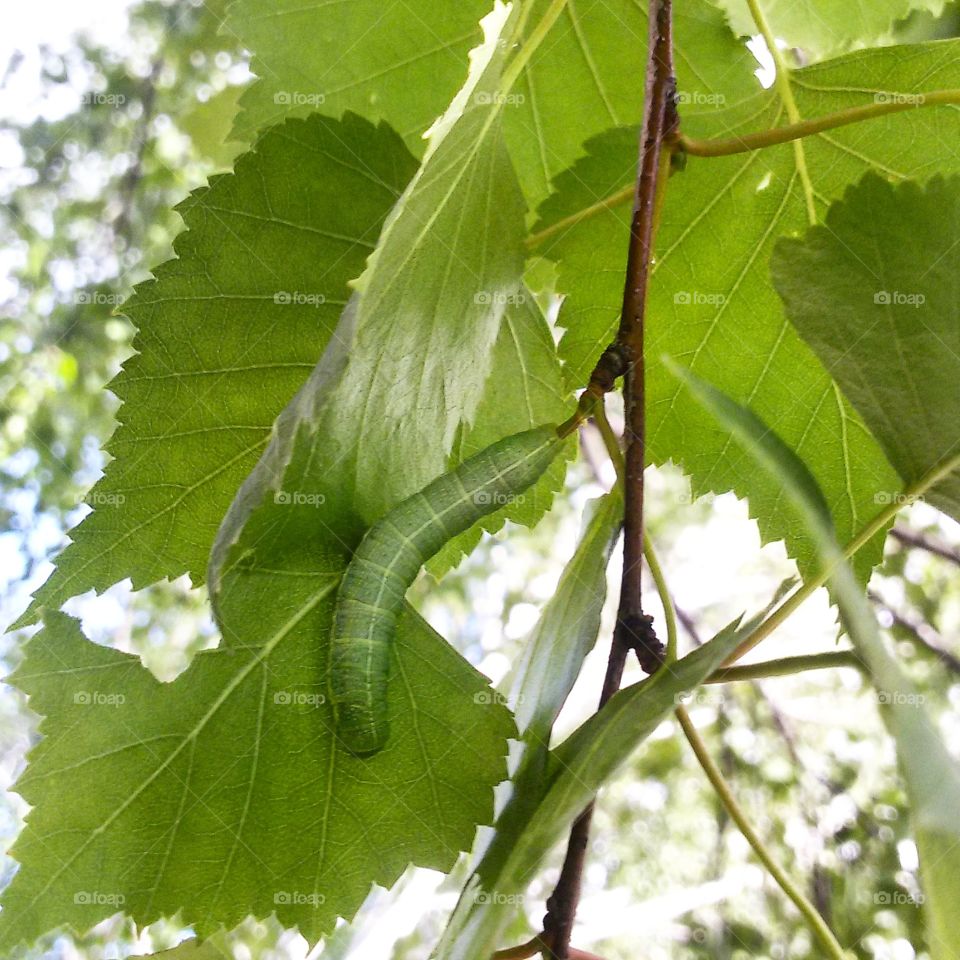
[543,0,679,960]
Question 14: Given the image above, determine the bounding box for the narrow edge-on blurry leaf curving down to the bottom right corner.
[673,367,960,960]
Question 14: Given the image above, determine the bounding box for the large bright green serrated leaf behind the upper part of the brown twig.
[538,41,960,578]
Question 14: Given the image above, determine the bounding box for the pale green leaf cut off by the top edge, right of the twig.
[718,0,944,60]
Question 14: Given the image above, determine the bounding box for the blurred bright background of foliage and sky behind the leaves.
[0,0,960,960]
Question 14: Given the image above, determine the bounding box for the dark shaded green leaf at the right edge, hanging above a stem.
[772,175,960,520]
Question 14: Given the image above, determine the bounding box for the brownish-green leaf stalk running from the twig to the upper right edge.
[680,90,960,158]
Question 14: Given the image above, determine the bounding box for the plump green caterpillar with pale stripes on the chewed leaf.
[330,425,563,754]
